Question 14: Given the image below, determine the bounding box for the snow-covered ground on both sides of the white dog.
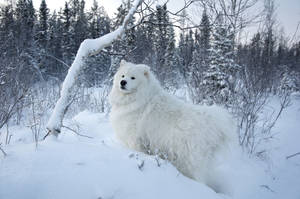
[0,97,300,199]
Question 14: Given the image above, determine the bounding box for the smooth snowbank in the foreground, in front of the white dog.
[0,111,221,199]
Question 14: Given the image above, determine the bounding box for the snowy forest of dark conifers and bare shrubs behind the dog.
[0,0,300,155]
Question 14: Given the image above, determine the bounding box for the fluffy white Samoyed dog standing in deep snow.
[109,61,235,193]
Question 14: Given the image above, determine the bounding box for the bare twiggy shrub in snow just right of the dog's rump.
[230,66,291,157]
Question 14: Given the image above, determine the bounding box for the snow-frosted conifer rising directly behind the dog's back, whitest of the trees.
[203,16,239,106]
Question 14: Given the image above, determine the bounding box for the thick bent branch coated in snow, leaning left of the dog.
[45,0,143,137]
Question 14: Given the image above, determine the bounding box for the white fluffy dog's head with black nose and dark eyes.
[114,60,150,94]
